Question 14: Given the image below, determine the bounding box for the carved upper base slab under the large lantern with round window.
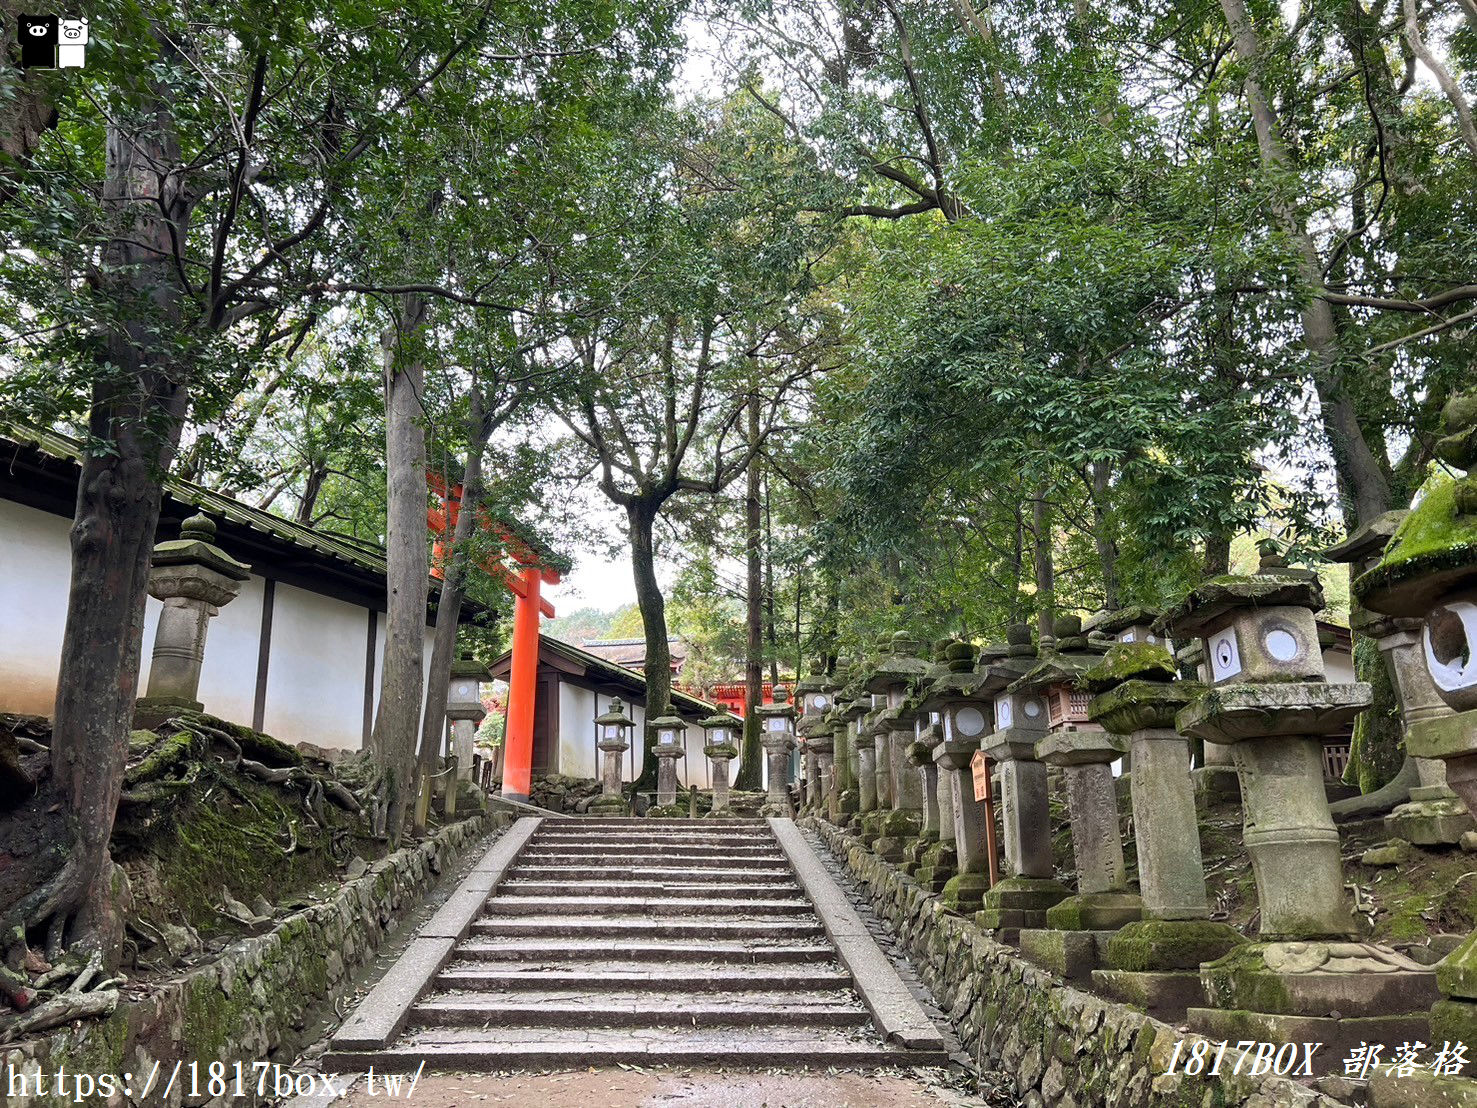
[1201,941,1441,1022]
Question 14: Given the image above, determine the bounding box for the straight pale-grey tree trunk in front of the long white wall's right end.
[369,293,430,842]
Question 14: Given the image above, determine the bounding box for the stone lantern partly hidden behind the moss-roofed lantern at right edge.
[1323,511,1474,847]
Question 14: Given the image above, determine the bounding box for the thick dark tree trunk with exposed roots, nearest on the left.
[0,93,189,969]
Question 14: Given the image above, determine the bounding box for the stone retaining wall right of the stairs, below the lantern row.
[805,818,1344,1108]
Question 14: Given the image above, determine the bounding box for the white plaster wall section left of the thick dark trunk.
[0,499,70,715]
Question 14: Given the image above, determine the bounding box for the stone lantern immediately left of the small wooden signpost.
[919,643,994,912]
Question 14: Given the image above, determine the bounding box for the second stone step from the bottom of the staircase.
[411,990,868,1030]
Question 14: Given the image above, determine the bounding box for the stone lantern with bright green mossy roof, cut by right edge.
[1353,393,1477,1075]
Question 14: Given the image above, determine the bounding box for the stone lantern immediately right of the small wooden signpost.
[976,623,1068,943]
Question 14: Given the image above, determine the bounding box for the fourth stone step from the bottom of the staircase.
[456,938,836,972]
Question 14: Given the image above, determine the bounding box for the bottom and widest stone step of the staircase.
[322,1027,948,1074]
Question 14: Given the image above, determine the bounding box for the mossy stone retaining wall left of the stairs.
[0,814,511,1108]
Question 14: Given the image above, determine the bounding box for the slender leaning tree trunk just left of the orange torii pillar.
[415,390,490,835]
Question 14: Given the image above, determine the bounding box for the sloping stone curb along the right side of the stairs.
[770,817,944,1050]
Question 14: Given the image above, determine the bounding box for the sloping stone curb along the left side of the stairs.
[332,817,542,1050]
